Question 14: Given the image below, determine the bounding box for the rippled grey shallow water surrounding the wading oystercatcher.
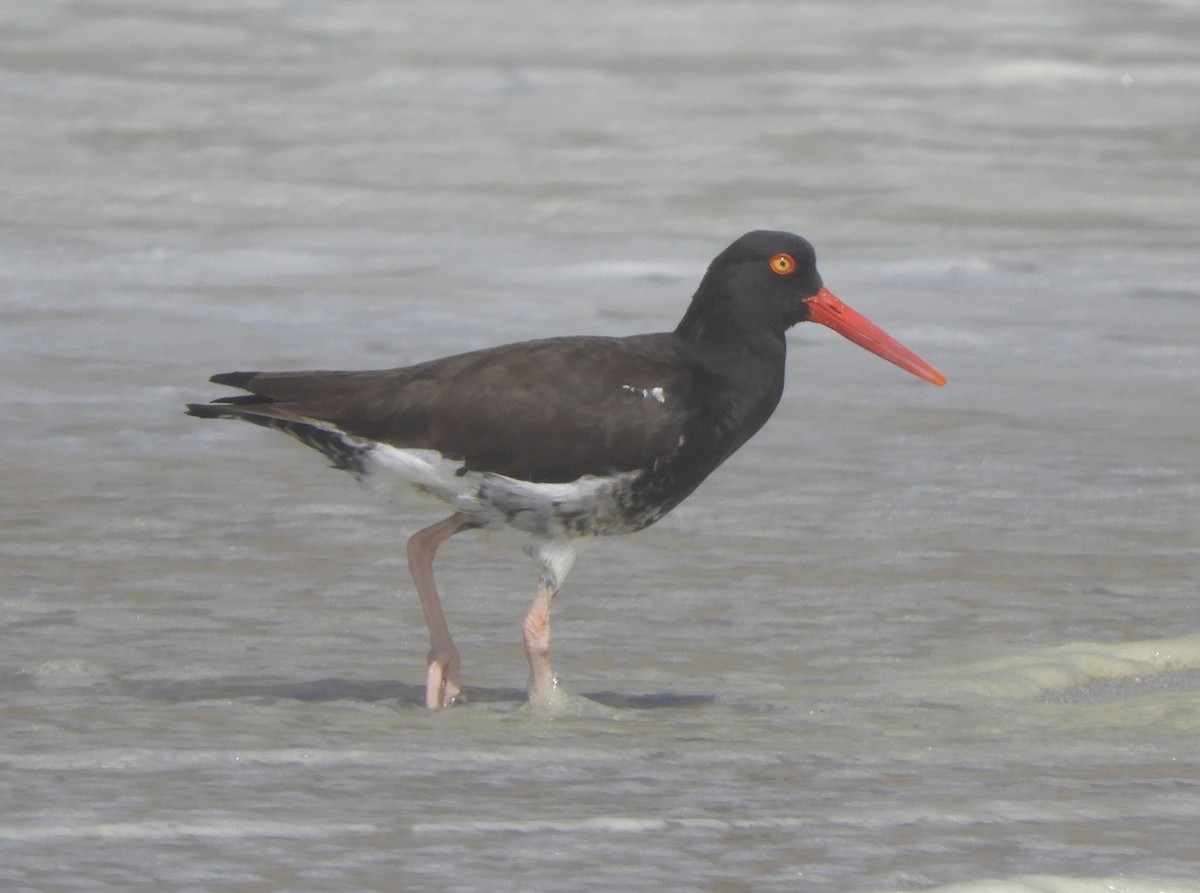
[0,0,1200,893]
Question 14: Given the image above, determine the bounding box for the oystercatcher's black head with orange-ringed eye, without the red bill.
[676,229,822,341]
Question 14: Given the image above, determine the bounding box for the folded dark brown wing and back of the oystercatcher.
[193,334,703,483]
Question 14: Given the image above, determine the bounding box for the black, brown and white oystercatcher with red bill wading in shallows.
[187,230,946,709]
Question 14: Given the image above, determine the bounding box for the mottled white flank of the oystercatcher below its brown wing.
[362,444,638,537]
